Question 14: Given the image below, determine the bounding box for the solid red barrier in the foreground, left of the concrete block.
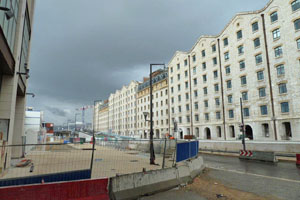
[0,178,109,200]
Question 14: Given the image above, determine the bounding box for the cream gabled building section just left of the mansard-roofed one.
[108,81,138,136]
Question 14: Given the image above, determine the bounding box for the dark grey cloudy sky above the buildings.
[27,0,268,124]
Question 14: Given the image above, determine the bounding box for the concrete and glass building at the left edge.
[0,0,35,162]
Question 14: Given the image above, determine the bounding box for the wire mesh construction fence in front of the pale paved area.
[0,138,195,185]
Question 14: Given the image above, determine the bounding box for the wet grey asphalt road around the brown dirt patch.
[141,154,300,200]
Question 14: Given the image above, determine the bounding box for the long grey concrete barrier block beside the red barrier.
[109,157,204,200]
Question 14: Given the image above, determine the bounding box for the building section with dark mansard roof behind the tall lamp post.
[137,69,169,138]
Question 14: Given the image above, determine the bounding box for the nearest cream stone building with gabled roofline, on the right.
[168,0,300,140]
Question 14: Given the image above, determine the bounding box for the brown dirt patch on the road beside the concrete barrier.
[183,169,277,200]
